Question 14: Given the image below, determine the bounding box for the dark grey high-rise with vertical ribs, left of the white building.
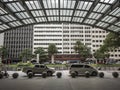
[4,26,33,59]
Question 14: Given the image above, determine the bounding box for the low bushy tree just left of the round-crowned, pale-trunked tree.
[34,47,48,63]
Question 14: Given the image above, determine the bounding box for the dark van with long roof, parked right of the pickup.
[69,64,98,76]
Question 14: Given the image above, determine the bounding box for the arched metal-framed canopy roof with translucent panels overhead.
[0,0,120,34]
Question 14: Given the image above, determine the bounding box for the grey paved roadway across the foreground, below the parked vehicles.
[0,71,120,90]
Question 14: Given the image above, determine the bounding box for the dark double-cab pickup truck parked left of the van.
[22,64,55,76]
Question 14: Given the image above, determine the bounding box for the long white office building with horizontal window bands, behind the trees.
[33,24,120,59]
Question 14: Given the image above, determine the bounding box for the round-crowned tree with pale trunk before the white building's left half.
[48,44,58,63]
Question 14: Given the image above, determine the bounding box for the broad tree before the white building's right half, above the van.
[74,41,91,60]
